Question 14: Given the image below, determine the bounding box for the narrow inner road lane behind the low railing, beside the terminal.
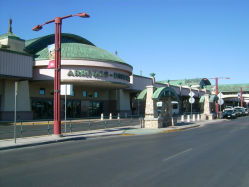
[0,118,140,140]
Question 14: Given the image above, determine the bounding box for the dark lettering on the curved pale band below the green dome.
[67,70,130,82]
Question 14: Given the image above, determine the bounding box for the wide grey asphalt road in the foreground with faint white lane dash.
[0,117,249,187]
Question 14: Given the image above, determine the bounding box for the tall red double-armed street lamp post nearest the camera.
[32,13,90,136]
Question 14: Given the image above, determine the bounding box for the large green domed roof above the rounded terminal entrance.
[25,33,130,66]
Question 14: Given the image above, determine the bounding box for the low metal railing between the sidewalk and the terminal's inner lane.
[0,115,142,139]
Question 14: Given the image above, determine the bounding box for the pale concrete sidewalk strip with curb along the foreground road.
[0,120,224,150]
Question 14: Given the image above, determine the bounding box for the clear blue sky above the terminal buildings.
[0,0,249,84]
